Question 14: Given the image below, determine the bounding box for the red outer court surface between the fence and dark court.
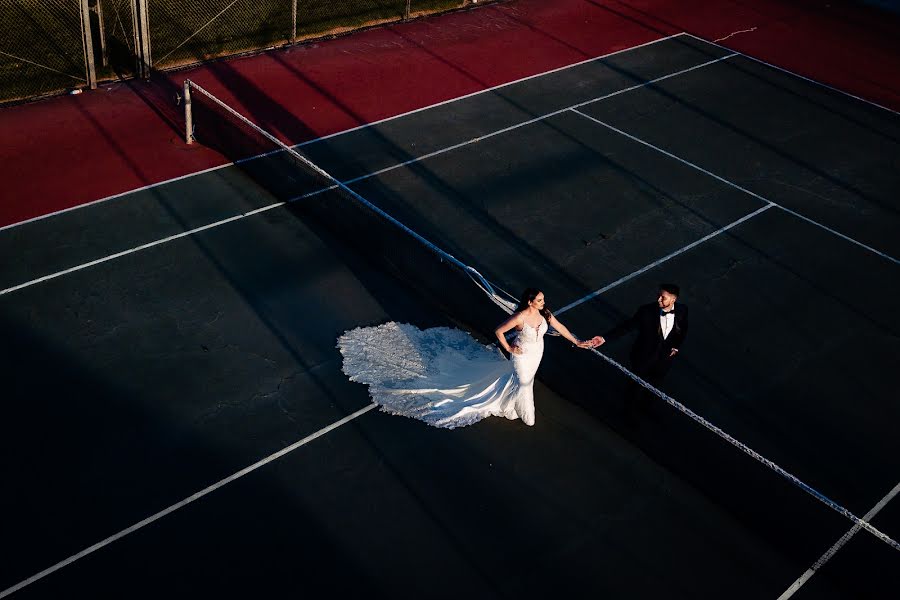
[0,0,900,226]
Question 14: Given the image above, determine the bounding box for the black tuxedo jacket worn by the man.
[603,302,688,369]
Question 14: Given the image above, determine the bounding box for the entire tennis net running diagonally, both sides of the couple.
[185,82,900,564]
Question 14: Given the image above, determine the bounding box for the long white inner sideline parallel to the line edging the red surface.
[0,54,737,296]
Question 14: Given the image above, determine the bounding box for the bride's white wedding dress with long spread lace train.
[337,317,547,428]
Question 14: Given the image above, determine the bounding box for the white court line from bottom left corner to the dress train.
[0,404,377,598]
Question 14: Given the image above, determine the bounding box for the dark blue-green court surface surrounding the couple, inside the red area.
[0,36,900,600]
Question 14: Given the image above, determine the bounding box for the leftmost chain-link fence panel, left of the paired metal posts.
[0,0,90,102]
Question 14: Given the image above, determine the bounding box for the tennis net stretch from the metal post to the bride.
[184,80,515,332]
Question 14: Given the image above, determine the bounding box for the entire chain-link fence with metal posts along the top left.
[0,0,472,102]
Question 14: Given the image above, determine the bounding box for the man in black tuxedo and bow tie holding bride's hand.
[597,283,688,421]
